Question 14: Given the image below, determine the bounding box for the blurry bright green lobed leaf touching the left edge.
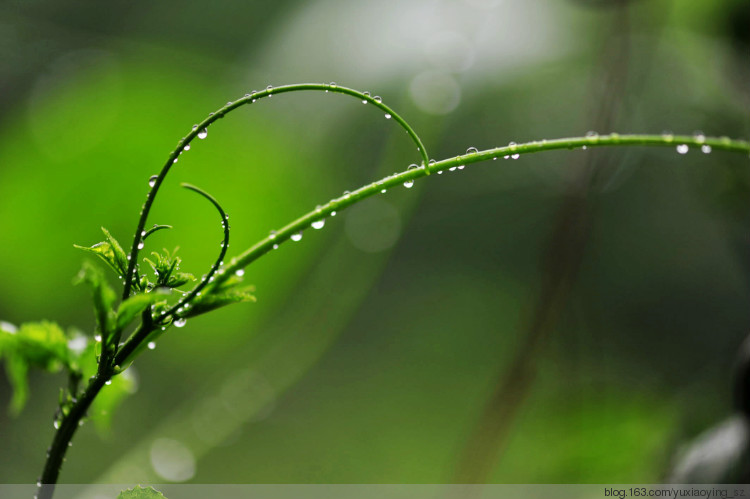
[0,321,72,415]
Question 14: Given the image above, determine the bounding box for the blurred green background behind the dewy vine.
[0,0,750,483]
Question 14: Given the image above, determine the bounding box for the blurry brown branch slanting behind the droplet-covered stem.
[452,3,630,483]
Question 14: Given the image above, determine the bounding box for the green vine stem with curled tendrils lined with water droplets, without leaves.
[38,83,750,499]
